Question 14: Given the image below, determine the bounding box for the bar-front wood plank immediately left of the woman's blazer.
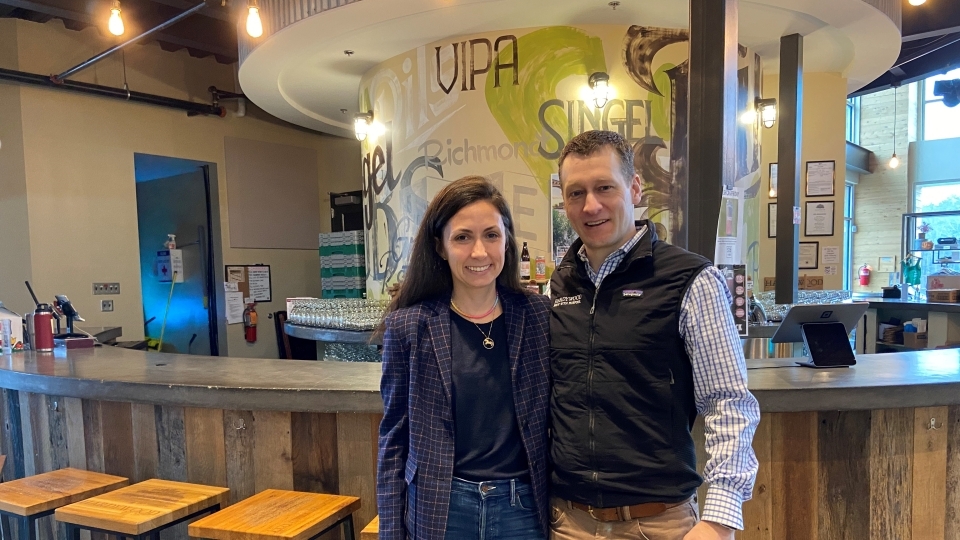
[337,413,382,530]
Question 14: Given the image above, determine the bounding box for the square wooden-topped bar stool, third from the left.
[187,489,360,540]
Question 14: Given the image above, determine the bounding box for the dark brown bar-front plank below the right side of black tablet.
[817,411,870,540]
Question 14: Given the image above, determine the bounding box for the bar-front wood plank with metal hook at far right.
[912,407,950,540]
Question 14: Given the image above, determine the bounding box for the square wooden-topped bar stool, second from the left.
[54,479,230,540]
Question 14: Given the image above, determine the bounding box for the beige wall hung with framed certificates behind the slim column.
[757,73,847,290]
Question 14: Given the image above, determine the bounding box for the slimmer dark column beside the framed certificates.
[775,34,803,304]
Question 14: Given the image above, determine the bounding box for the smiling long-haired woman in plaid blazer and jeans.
[377,176,550,540]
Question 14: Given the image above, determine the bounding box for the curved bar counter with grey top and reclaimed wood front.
[0,347,960,540]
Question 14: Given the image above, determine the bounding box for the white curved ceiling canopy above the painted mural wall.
[239,0,900,137]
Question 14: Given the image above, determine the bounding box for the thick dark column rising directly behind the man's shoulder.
[684,0,737,260]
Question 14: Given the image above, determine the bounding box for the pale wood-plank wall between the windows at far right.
[853,88,913,292]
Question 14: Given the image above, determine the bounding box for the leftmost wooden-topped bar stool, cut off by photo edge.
[0,468,130,540]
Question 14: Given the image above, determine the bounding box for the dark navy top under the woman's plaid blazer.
[450,311,529,482]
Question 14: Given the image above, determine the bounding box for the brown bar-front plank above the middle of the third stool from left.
[253,411,293,492]
